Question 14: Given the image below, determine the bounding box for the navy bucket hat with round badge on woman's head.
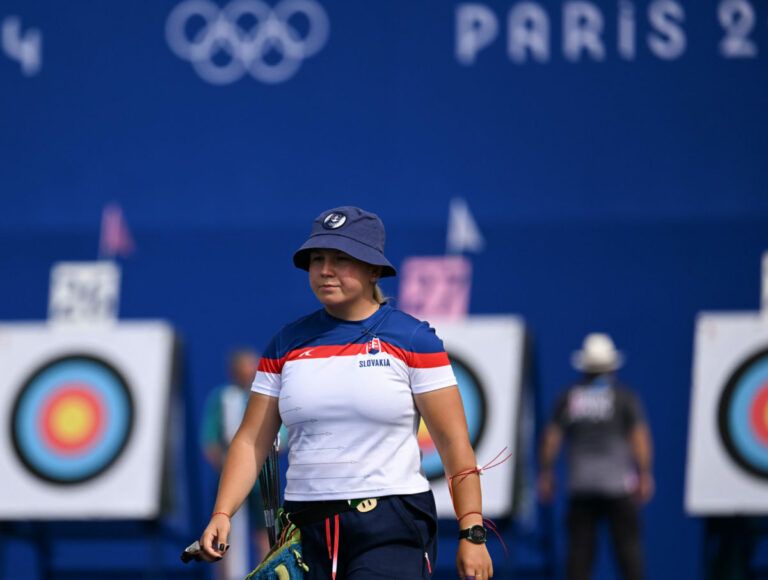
[293,205,397,278]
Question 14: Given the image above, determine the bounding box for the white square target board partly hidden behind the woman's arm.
[419,315,525,518]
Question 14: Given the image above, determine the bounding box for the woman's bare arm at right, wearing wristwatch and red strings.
[414,385,493,580]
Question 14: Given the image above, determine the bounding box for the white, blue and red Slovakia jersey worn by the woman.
[252,304,456,501]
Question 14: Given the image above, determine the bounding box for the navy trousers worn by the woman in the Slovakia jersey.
[285,491,437,580]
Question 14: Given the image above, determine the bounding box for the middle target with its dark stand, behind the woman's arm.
[418,315,554,580]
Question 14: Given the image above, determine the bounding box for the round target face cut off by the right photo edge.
[718,349,768,479]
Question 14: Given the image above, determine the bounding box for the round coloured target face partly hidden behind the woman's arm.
[418,353,486,481]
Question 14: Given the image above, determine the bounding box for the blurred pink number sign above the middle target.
[398,256,472,319]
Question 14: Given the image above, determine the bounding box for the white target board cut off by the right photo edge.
[685,313,768,515]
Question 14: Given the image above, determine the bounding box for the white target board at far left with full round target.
[0,321,174,520]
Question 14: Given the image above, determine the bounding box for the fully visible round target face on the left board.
[9,354,133,484]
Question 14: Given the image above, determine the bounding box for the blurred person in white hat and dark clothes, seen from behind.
[538,333,655,580]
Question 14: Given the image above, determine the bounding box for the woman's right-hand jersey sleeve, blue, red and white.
[406,322,456,394]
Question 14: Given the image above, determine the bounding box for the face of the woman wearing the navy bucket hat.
[309,249,378,320]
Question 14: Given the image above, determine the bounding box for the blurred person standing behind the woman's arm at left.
[201,349,269,580]
